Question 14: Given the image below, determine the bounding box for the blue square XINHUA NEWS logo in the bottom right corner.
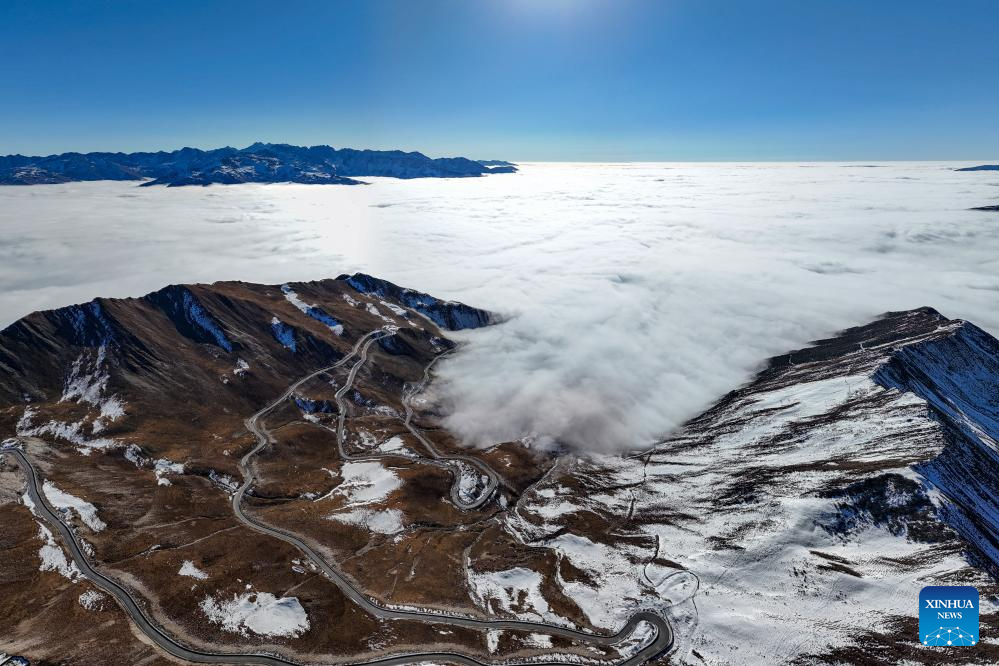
[919,585,978,647]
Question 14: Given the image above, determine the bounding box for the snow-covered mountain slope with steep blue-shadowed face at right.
[470,308,999,664]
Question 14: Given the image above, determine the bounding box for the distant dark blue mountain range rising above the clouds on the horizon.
[0,142,516,187]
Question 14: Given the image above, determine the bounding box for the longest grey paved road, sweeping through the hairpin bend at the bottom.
[0,330,673,666]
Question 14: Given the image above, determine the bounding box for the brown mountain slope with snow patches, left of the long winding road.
[0,274,528,664]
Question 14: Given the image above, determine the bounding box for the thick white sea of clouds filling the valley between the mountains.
[0,163,999,450]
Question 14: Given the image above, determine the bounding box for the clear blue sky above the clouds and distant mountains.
[0,0,999,161]
